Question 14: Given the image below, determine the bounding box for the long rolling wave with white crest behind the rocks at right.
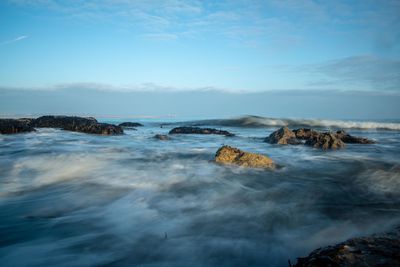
[190,116,400,131]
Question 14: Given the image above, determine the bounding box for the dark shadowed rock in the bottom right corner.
[294,227,400,267]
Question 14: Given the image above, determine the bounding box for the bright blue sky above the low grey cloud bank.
[0,0,400,117]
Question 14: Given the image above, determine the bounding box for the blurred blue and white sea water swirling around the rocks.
[0,117,400,267]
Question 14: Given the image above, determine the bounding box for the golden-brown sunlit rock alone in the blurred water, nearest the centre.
[215,146,275,169]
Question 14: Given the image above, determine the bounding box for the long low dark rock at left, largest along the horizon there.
[33,116,124,135]
